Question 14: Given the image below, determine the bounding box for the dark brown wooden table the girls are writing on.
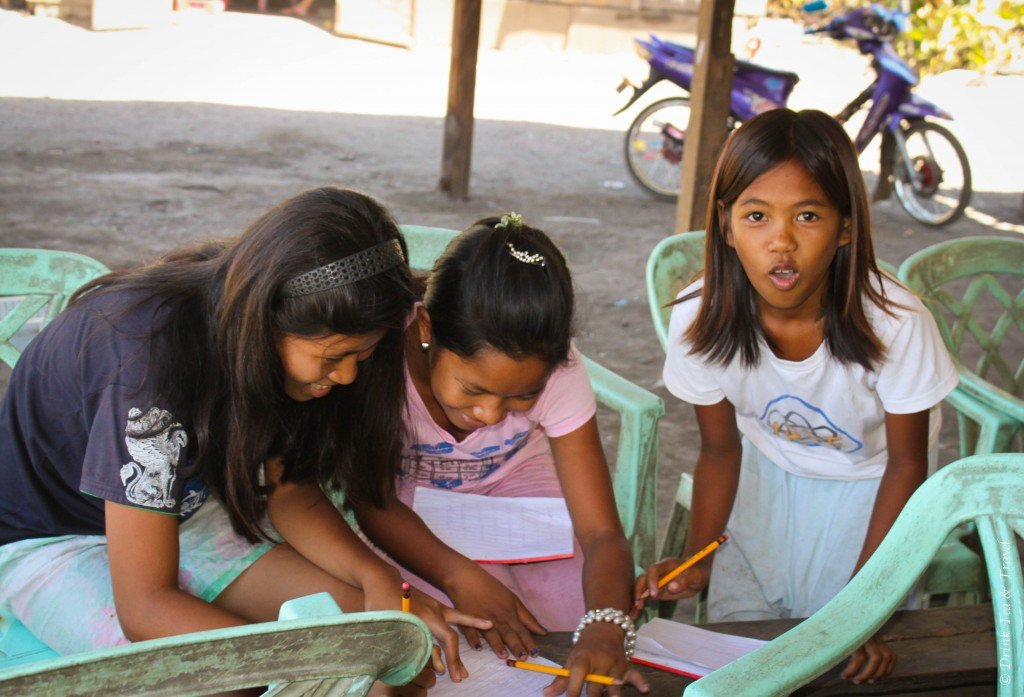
[538,604,996,697]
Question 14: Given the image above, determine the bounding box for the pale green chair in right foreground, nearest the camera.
[683,453,1024,697]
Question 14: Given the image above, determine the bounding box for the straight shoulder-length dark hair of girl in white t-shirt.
[678,108,891,371]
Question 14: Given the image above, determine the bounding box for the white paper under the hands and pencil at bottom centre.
[430,638,558,697]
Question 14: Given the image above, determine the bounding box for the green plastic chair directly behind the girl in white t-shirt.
[647,230,985,624]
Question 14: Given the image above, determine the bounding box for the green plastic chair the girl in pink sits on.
[401,225,665,567]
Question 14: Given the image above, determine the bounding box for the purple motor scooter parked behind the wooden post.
[616,2,971,225]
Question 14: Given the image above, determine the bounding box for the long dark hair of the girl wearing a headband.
[75,187,415,541]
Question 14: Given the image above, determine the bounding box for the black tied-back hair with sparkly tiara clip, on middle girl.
[423,214,574,366]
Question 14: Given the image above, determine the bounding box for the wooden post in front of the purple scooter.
[676,0,735,232]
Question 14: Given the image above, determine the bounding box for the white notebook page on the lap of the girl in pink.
[413,486,572,564]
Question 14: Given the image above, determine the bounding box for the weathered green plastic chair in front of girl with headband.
[0,594,432,697]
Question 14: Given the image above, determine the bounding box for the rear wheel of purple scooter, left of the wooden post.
[626,97,690,201]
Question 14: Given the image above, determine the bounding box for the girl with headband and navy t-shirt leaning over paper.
[0,188,490,694]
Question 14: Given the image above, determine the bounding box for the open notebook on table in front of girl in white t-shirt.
[631,618,767,678]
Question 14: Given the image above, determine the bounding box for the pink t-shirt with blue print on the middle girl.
[400,347,597,491]
